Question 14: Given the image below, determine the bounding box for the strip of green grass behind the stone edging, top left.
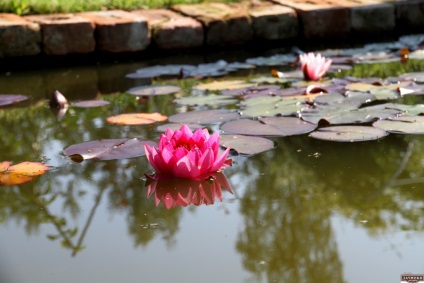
[0,0,234,15]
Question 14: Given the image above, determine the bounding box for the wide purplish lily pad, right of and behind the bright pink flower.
[221,117,317,136]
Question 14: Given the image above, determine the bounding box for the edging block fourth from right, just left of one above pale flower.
[243,2,299,40]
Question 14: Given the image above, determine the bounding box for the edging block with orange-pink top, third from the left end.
[77,10,150,52]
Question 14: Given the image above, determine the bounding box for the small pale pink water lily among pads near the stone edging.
[299,52,332,81]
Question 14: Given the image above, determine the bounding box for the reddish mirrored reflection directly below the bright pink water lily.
[146,173,233,209]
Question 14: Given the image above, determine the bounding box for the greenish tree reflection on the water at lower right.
[237,135,424,282]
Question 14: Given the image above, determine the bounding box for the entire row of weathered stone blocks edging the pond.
[0,0,424,58]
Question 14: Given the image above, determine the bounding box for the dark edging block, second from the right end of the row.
[350,3,395,35]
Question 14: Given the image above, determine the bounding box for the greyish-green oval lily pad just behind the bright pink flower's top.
[169,109,240,124]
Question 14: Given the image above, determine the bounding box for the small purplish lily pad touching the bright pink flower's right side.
[220,135,275,155]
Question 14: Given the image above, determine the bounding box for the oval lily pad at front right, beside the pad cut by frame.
[309,126,387,142]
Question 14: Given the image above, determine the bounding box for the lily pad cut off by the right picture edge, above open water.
[373,116,424,134]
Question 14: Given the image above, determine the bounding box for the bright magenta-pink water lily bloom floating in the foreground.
[144,125,231,180]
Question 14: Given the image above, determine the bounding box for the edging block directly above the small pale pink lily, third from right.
[274,0,350,39]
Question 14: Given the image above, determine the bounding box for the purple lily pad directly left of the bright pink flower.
[63,139,157,162]
